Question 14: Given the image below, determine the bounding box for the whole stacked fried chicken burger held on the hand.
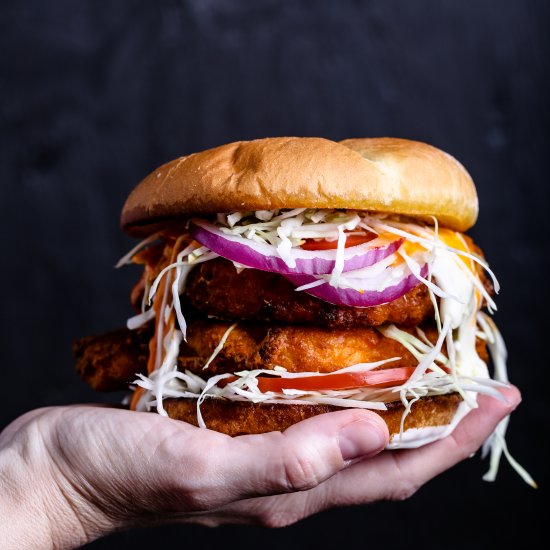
[75,137,507,462]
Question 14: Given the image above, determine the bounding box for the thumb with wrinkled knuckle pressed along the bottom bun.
[211,409,389,500]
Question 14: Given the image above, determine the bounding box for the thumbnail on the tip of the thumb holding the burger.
[338,420,387,462]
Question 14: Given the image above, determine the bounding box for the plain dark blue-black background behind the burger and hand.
[0,0,550,549]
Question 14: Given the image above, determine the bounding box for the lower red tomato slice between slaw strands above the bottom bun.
[252,367,414,393]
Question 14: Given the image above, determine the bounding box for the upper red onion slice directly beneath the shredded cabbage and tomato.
[191,220,403,275]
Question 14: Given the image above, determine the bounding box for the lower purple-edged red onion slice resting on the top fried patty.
[285,265,428,307]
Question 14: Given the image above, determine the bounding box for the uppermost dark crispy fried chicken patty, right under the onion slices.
[186,258,433,328]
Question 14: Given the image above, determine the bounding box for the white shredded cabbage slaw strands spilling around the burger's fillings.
[119,208,534,485]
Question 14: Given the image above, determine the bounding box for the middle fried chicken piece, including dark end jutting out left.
[75,320,488,390]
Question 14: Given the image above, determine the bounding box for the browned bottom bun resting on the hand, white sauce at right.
[163,393,470,448]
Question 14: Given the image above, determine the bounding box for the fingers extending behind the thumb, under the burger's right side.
[207,387,520,527]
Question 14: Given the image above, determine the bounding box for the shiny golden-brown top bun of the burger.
[121,137,478,236]
